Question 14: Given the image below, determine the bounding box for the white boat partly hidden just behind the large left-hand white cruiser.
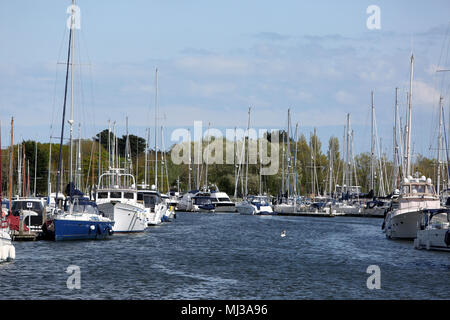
[137,189,167,226]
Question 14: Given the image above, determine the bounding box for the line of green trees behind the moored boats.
[1,130,437,197]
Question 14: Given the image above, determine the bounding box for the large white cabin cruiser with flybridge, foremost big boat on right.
[382,176,442,239]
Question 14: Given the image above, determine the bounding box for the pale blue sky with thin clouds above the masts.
[0,0,450,156]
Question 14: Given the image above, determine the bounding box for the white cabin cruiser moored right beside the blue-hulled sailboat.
[95,168,147,233]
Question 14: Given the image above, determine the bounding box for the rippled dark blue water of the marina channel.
[0,213,450,300]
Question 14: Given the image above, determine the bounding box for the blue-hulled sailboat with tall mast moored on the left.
[42,0,114,241]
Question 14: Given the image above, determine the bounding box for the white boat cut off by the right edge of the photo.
[414,208,450,251]
